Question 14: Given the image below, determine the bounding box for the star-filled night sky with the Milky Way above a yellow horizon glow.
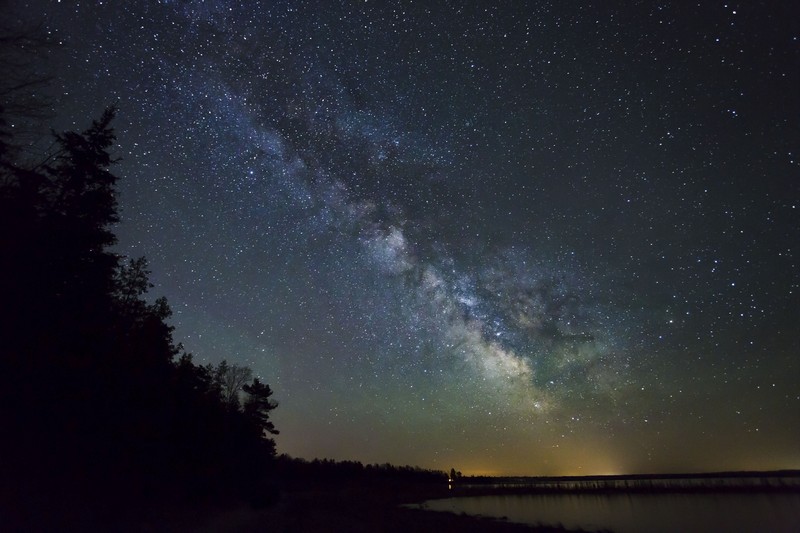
[14,0,800,475]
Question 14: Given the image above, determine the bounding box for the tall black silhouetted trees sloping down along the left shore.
[0,103,277,524]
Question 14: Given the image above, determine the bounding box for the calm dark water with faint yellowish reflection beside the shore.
[421,493,800,533]
